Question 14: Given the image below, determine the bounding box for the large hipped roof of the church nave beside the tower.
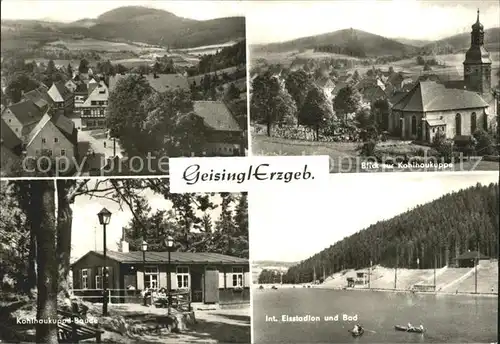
[393,81,488,112]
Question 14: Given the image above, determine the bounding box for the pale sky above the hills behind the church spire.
[247,0,500,44]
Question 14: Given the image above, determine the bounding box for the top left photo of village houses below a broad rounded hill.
[0,0,248,178]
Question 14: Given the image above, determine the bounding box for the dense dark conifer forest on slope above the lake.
[283,184,499,283]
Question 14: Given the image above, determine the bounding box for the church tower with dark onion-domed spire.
[464,10,491,94]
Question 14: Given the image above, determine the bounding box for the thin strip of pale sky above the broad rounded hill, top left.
[2,0,244,22]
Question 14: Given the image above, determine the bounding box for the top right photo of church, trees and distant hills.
[247,1,500,173]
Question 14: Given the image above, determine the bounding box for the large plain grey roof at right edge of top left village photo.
[193,101,241,131]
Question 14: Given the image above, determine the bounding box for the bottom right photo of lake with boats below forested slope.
[249,172,499,344]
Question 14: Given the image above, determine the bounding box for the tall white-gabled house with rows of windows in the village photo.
[77,81,109,129]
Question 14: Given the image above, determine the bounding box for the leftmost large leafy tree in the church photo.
[250,73,297,136]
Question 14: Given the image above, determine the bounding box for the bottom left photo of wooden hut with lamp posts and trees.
[0,178,252,343]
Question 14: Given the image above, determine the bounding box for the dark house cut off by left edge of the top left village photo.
[0,119,23,176]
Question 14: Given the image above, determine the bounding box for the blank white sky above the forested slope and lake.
[248,171,498,262]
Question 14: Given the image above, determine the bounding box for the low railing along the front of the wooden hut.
[71,289,191,311]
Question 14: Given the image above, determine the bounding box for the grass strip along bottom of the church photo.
[252,134,499,173]
